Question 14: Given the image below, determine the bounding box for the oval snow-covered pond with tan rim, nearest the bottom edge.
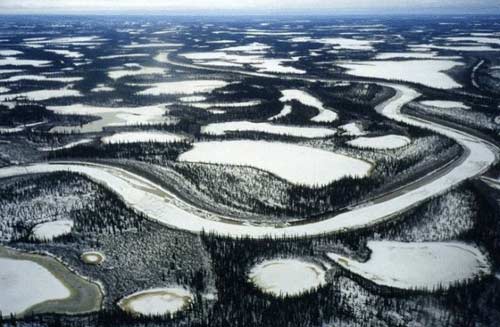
[118,287,193,316]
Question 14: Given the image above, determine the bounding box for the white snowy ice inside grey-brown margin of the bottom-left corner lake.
[0,258,71,316]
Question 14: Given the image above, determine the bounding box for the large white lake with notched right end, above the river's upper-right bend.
[336,60,463,89]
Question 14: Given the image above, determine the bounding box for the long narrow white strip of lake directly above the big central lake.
[201,121,337,138]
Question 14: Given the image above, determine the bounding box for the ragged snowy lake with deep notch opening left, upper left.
[47,104,170,133]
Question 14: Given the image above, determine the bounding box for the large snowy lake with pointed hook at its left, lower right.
[327,241,491,291]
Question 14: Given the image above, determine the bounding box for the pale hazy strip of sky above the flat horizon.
[0,0,500,14]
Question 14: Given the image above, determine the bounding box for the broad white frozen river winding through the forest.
[0,80,498,238]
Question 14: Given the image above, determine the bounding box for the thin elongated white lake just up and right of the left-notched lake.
[137,80,229,95]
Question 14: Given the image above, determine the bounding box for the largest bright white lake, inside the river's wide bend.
[178,141,372,187]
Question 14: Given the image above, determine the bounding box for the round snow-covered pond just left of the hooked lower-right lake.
[248,259,326,296]
